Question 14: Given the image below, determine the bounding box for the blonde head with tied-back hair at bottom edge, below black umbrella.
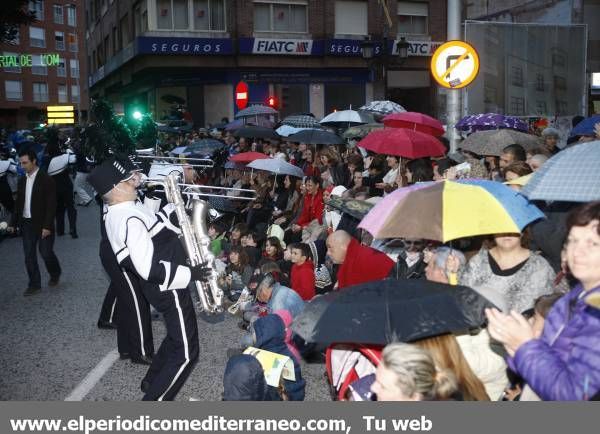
[371,343,457,401]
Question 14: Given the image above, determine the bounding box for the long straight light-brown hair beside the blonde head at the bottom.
[414,334,490,401]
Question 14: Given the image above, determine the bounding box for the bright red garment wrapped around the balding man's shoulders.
[338,238,394,289]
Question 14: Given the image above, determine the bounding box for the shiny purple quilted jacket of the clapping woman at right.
[508,285,600,401]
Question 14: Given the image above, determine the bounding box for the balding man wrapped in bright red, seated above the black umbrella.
[327,230,394,289]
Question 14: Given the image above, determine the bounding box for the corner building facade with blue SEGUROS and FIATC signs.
[86,0,446,126]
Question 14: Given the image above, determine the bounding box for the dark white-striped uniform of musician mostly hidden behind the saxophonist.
[100,205,154,359]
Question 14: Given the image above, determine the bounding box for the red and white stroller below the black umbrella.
[325,344,383,401]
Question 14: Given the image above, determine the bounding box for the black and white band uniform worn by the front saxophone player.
[105,201,199,401]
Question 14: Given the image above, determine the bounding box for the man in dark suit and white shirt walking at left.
[9,149,61,297]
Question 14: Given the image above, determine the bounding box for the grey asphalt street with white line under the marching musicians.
[0,205,329,401]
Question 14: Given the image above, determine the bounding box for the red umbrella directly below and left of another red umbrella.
[358,128,446,159]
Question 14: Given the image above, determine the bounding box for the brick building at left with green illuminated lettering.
[0,0,89,129]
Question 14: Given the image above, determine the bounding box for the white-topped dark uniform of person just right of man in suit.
[48,150,77,235]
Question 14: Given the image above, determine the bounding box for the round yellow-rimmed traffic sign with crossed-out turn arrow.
[431,41,479,89]
